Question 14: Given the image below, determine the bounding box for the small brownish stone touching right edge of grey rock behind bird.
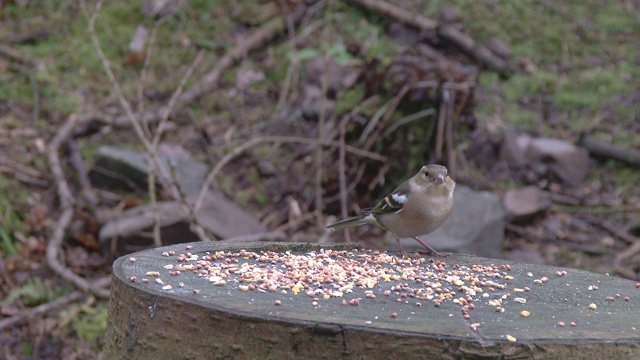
[502,186,551,223]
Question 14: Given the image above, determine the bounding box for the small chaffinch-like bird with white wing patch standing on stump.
[327,164,456,257]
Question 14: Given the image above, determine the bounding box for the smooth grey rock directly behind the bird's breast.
[393,185,504,258]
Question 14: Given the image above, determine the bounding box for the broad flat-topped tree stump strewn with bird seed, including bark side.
[103,242,640,359]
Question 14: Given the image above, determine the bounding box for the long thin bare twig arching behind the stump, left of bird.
[194,136,387,211]
